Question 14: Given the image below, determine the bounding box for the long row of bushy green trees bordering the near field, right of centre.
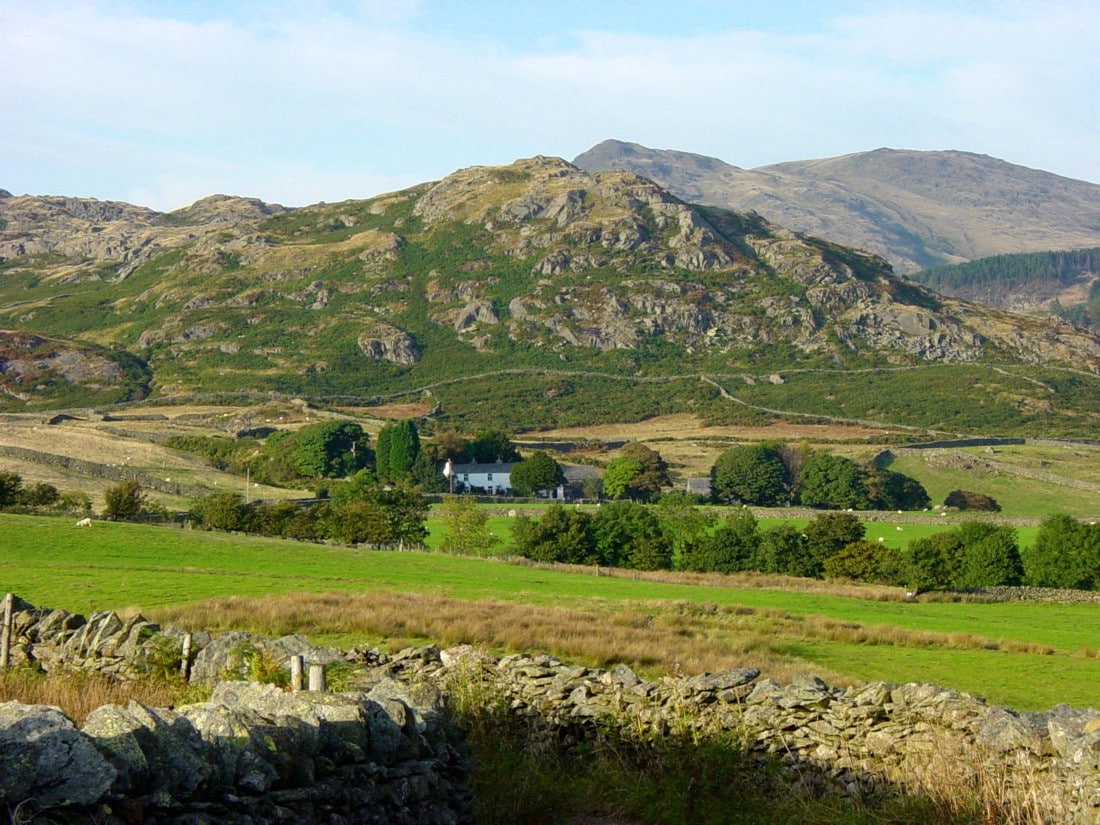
[512,503,1100,592]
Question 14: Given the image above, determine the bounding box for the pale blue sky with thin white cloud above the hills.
[0,0,1100,211]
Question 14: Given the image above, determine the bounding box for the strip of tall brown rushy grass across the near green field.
[154,592,1078,704]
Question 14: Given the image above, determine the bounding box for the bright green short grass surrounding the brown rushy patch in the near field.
[0,514,1100,710]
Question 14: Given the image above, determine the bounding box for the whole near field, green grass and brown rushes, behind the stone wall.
[0,515,1100,710]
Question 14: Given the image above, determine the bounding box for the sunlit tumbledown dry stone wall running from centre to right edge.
[376,648,1100,825]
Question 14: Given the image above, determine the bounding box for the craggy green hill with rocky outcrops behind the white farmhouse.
[0,157,1100,428]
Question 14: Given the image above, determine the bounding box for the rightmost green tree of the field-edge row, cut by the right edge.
[1023,514,1100,590]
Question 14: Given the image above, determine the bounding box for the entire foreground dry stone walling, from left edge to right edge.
[0,602,1100,825]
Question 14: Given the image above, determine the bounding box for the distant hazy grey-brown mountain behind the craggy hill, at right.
[573,141,1100,274]
